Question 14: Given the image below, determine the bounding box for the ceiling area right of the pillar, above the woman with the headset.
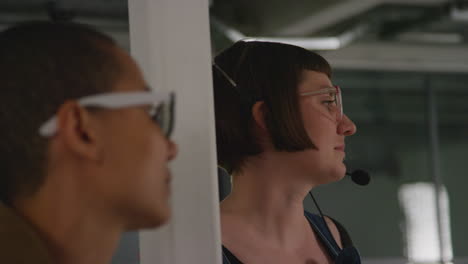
[211,0,468,73]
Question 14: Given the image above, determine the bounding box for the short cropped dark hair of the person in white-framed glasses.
[0,21,121,204]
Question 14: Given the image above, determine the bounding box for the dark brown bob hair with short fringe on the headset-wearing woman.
[213,41,331,173]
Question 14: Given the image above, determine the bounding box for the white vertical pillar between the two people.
[128,0,221,264]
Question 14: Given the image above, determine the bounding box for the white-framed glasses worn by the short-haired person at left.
[39,91,175,137]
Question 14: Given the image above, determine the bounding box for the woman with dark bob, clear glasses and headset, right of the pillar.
[213,41,360,264]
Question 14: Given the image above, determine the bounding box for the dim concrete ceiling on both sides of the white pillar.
[0,0,468,73]
